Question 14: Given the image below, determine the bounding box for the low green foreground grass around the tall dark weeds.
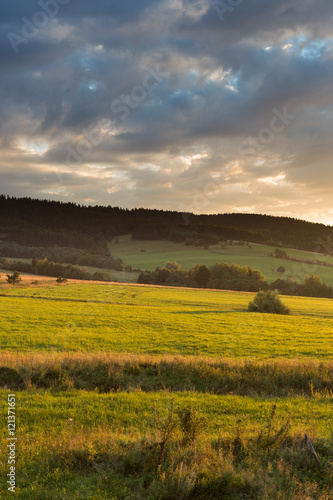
[0,390,332,499]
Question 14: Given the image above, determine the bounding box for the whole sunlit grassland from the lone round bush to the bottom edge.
[0,281,333,500]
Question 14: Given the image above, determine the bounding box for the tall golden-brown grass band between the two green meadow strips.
[0,352,333,397]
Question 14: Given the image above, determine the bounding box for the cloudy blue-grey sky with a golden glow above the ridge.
[0,0,333,225]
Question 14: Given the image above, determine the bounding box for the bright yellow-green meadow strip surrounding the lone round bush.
[0,284,333,358]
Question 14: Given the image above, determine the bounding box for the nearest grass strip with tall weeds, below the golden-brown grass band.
[0,391,333,500]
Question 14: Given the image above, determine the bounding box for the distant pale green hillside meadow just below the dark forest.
[109,235,333,286]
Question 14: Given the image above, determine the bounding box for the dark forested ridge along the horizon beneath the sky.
[0,195,333,253]
